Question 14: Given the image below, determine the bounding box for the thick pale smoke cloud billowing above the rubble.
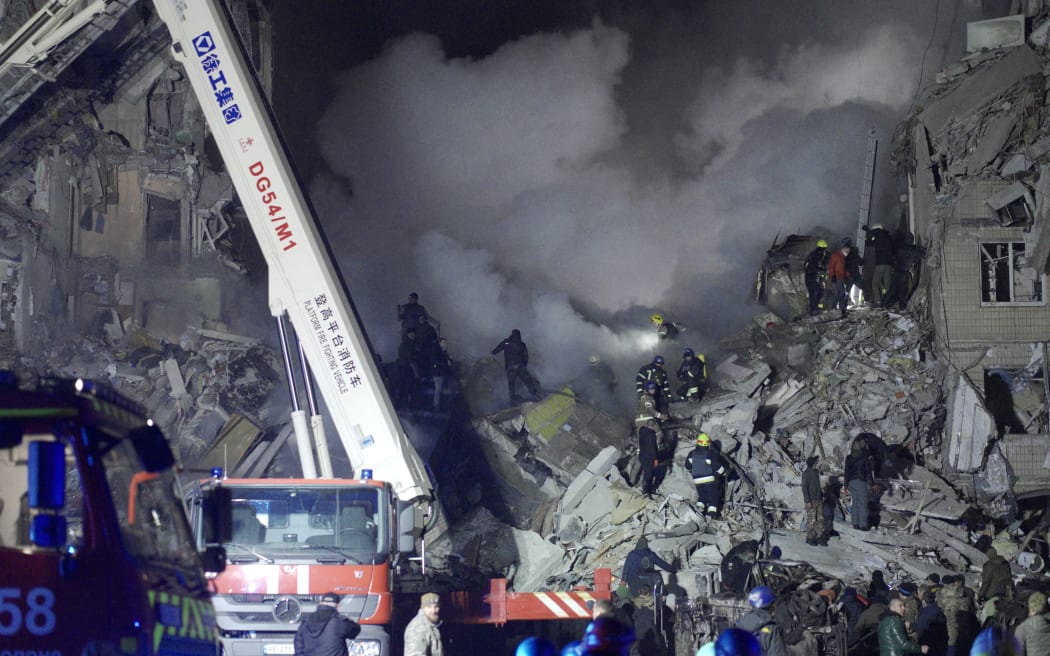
[311,3,982,407]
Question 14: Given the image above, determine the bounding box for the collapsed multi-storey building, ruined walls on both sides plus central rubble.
[0,1,1050,653]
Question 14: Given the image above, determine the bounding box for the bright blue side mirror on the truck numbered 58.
[28,441,66,548]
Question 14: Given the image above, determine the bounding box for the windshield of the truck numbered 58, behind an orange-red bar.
[102,440,201,570]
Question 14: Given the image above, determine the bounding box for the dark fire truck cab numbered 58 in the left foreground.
[0,377,228,656]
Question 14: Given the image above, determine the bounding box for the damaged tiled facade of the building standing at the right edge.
[896,11,1050,515]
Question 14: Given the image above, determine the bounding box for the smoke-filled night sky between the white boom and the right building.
[264,0,1008,409]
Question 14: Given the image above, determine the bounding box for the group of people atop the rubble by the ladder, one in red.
[803,224,922,317]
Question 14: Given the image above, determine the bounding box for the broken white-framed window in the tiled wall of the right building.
[979,241,1044,305]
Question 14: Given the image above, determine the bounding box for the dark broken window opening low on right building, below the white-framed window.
[984,368,1048,436]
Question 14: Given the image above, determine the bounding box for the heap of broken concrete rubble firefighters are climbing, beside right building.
[431,298,1041,598]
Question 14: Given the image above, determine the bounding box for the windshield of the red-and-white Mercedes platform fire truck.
[227,485,387,562]
